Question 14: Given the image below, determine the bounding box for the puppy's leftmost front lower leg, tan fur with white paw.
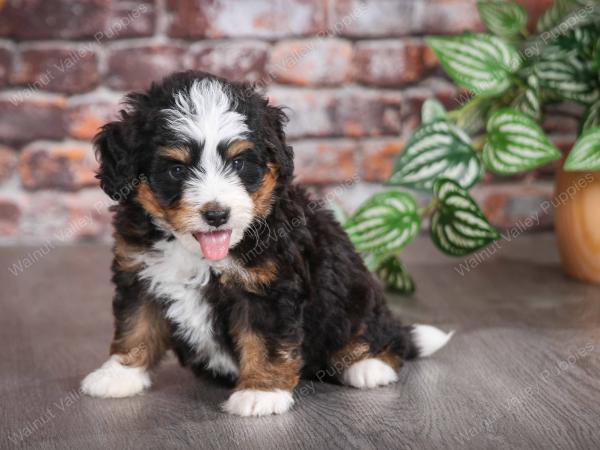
[81,303,169,398]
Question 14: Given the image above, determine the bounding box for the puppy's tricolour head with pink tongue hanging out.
[95,72,293,260]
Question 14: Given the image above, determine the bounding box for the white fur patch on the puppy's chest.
[139,240,238,376]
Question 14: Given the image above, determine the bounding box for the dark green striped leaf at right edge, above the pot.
[535,46,600,104]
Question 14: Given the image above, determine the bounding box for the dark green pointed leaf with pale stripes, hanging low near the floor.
[429,178,500,256]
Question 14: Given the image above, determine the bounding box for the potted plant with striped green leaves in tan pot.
[344,0,600,293]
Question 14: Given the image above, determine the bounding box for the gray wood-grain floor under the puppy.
[0,235,600,450]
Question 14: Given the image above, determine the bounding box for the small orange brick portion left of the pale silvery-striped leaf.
[360,138,404,183]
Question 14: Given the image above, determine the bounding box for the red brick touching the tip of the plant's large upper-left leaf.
[354,40,432,87]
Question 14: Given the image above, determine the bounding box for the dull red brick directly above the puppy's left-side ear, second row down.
[106,45,185,90]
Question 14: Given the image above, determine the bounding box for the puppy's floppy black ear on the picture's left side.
[94,114,137,202]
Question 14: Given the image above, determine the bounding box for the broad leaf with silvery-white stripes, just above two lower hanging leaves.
[388,120,483,191]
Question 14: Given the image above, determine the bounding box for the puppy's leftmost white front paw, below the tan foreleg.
[81,355,151,398]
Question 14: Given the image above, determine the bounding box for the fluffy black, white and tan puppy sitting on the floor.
[82,72,450,416]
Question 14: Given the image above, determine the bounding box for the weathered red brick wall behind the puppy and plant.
[0,0,574,243]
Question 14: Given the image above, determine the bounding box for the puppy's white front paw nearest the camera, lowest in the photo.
[223,389,294,417]
